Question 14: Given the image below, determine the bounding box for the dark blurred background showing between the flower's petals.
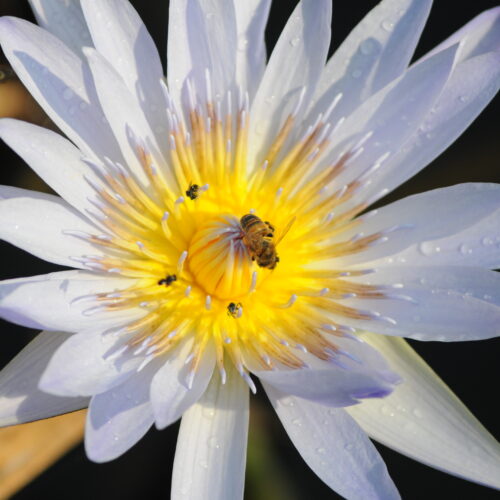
[0,0,500,500]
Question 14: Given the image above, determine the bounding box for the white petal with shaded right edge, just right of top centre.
[249,0,332,165]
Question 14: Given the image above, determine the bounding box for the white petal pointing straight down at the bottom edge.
[171,370,249,500]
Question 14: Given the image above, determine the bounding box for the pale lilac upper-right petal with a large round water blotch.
[309,0,432,129]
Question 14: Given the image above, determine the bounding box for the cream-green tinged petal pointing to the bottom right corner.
[348,335,500,488]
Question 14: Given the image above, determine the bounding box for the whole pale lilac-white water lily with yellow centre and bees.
[0,0,500,500]
